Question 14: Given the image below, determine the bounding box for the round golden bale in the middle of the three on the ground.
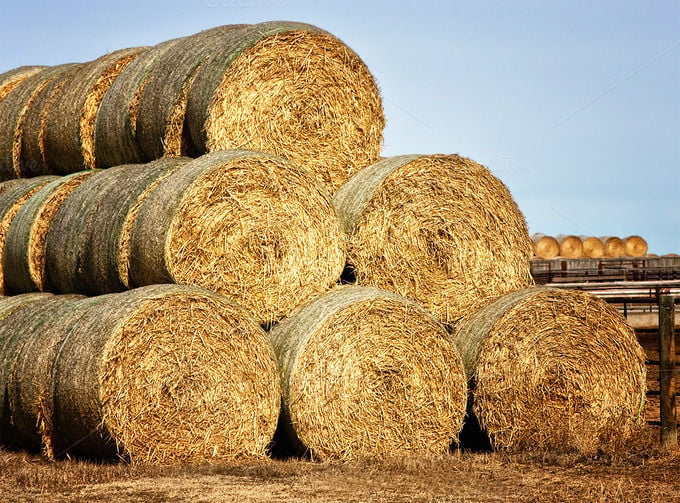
[270,286,467,459]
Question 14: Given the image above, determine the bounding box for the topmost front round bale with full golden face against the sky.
[199,22,385,194]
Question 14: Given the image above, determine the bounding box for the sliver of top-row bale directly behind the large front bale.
[137,25,246,159]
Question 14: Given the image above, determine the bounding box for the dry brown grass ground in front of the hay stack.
[0,430,680,503]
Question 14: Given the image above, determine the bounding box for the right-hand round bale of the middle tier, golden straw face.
[334,155,532,323]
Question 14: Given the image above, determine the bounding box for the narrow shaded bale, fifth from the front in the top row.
[20,64,82,178]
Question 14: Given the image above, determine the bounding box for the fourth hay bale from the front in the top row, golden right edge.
[44,47,146,175]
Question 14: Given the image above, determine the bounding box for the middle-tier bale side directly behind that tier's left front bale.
[45,158,189,295]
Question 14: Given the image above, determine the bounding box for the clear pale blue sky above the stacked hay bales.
[0,0,680,254]
